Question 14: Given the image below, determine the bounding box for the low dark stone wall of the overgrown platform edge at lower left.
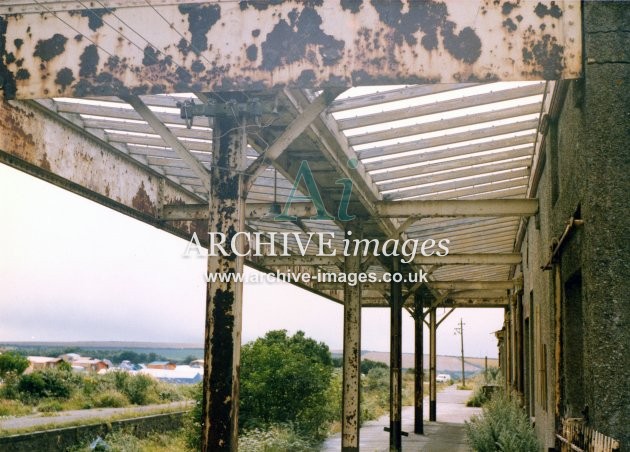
[0,412,187,452]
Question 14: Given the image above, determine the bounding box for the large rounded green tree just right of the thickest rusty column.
[239,330,335,437]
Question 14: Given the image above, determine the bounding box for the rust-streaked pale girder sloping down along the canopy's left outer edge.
[0,101,206,241]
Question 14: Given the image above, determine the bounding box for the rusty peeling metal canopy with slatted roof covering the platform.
[0,0,580,306]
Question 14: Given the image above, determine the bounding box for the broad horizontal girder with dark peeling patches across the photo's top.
[0,0,582,99]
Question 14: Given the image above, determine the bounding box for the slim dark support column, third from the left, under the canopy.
[389,259,403,451]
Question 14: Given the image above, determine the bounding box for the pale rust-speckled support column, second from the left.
[341,222,361,452]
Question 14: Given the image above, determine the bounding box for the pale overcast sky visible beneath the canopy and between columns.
[0,164,503,357]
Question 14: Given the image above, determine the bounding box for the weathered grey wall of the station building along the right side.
[521,2,630,450]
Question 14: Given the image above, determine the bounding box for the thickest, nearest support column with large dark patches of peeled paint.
[201,112,247,451]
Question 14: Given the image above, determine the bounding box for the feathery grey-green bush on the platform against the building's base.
[466,391,539,452]
